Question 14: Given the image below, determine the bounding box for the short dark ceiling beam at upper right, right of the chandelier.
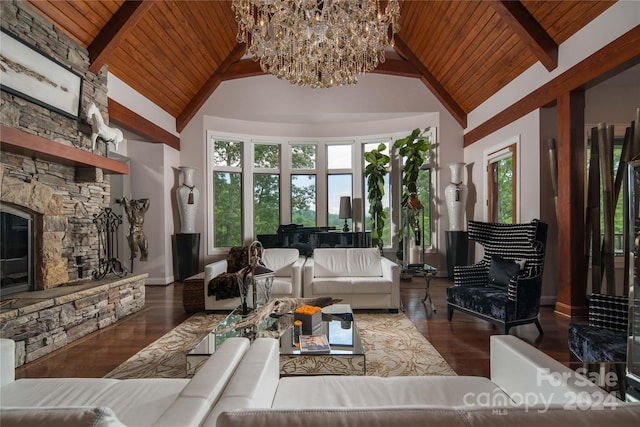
[489,0,558,71]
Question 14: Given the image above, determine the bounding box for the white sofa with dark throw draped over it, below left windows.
[204,248,305,311]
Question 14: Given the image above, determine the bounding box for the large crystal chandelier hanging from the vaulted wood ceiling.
[232,0,400,88]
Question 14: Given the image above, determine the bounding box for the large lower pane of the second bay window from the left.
[253,174,280,239]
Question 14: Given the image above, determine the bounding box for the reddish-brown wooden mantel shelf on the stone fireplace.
[0,125,129,175]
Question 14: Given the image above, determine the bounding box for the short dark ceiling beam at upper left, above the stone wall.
[88,0,153,74]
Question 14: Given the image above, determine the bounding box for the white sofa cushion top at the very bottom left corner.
[0,406,124,427]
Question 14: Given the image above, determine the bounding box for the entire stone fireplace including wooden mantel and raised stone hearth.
[0,0,148,366]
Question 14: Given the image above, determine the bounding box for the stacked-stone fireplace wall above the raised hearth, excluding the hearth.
[0,0,111,291]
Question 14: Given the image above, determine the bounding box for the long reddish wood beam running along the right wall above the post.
[464,25,640,147]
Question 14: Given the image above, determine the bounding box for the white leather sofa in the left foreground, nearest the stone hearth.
[0,338,255,427]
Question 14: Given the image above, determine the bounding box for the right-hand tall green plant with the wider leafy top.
[393,128,431,206]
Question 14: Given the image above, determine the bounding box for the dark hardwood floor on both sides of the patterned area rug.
[16,278,569,378]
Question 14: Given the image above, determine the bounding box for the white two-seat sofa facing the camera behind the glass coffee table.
[302,248,400,311]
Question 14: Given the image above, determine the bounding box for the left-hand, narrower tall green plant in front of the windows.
[364,144,390,252]
